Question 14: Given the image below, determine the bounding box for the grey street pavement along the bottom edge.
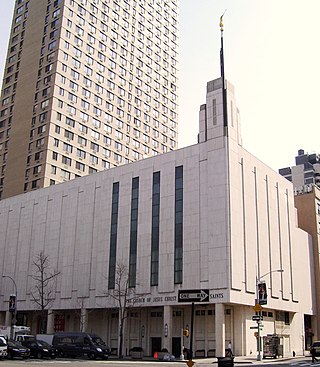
[0,357,320,367]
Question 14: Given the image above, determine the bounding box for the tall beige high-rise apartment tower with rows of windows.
[0,0,179,199]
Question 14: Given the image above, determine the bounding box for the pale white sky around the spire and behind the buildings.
[0,0,320,171]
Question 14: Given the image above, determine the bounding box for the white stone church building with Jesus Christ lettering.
[0,79,316,356]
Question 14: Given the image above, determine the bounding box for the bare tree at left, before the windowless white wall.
[30,251,60,333]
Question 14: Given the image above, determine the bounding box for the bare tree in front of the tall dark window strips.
[106,264,136,358]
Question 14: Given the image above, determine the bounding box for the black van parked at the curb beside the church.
[52,332,110,359]
